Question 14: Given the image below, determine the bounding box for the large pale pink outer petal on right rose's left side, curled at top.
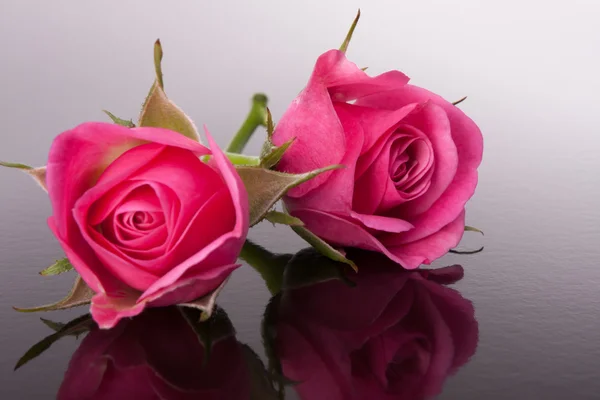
[273,50,408,197]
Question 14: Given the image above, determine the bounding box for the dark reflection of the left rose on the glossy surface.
[57,307,250,400]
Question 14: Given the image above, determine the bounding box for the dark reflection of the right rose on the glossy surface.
[276,255,478,400]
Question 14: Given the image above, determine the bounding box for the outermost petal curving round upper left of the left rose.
[46,123,209,292]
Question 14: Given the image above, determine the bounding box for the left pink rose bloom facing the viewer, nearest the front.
[46,123,248,328]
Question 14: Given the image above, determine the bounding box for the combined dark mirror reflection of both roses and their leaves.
[17,249,479,400]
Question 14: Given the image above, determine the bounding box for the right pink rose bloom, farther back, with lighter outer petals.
[273,50,483,269]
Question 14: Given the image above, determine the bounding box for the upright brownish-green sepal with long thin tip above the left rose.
[138,40,200,141]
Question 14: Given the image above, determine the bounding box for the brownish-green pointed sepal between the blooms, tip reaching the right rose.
[237,165,342,226]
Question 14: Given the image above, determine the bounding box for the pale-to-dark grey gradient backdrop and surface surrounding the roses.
[0,0,600,399]
